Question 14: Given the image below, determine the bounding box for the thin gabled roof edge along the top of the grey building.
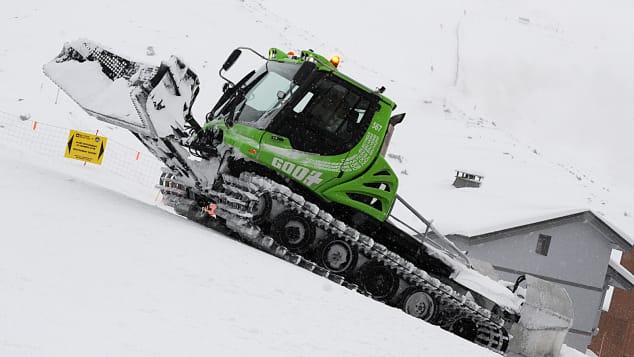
[460,209,634,251]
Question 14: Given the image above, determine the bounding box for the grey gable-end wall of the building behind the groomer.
[454,218,612,352]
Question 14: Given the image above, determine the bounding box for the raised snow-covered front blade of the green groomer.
[44,40,199,138]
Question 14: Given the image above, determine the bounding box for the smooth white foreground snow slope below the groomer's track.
[0,147,495,356]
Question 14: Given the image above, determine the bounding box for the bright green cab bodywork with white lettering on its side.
[204,48,398,221]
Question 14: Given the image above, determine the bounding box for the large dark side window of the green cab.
[289,77,374,155]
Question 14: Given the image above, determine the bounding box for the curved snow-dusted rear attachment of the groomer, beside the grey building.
[508,275,573,357]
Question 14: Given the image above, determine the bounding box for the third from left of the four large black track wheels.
[359,262,398,301]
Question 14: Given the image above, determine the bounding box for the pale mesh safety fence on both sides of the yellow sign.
[0,110,163,186]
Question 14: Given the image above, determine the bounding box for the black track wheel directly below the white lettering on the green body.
[271,211,315,253]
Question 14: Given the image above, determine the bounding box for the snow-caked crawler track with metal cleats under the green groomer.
[199,173,508,353]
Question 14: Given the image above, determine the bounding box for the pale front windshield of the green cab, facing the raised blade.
[233,62,299,126]
